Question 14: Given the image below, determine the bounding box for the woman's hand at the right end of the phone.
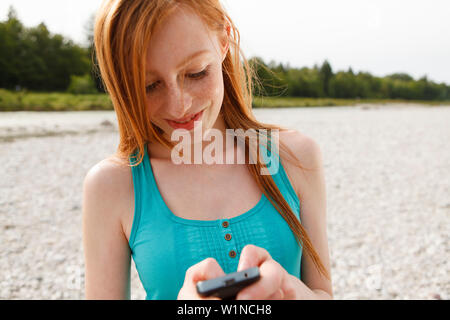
[236,245,300,300]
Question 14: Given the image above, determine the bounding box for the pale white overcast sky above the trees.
[0,0,450,84]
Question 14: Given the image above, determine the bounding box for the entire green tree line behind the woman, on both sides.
[0,8,450,100]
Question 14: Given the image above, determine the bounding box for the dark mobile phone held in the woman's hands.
[197,267,260,300]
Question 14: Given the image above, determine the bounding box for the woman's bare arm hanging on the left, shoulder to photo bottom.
[83,160,131,300]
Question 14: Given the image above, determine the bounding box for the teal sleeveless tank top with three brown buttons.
[129,145,302,300]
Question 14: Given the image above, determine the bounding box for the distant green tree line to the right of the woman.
[250,57,450,100]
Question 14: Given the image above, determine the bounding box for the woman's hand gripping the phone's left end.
[177,258,225,300]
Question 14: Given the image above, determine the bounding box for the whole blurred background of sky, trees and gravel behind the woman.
[0,0,450,299]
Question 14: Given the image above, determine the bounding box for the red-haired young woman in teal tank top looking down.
[83,0,332,299]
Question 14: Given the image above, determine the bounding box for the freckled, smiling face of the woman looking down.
[145,7,228,141]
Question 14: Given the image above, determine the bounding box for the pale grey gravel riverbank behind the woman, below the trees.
[0,105,450,299]
